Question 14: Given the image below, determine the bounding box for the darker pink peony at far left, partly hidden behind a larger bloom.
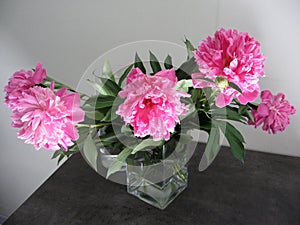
[4,63,47,110]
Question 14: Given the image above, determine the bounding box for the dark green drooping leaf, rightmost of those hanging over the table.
[219,122,245,162]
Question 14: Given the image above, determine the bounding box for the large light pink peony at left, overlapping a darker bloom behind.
[12,85,84,150]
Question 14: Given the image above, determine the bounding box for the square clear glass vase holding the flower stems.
[126,160,188,210]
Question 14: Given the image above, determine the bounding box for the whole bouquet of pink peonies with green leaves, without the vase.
[4,29,296,177]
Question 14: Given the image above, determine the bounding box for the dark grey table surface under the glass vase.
[4,145,300,225]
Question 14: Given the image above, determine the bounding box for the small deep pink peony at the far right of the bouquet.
[249,90,296,134]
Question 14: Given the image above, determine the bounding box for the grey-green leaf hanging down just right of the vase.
[204,125,220,163]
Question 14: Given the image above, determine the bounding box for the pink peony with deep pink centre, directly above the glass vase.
[117,68,190,140]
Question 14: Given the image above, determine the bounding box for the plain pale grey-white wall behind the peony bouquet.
[0,0,300,216]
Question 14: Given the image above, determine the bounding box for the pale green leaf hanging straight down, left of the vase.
[83,134,98,171]
